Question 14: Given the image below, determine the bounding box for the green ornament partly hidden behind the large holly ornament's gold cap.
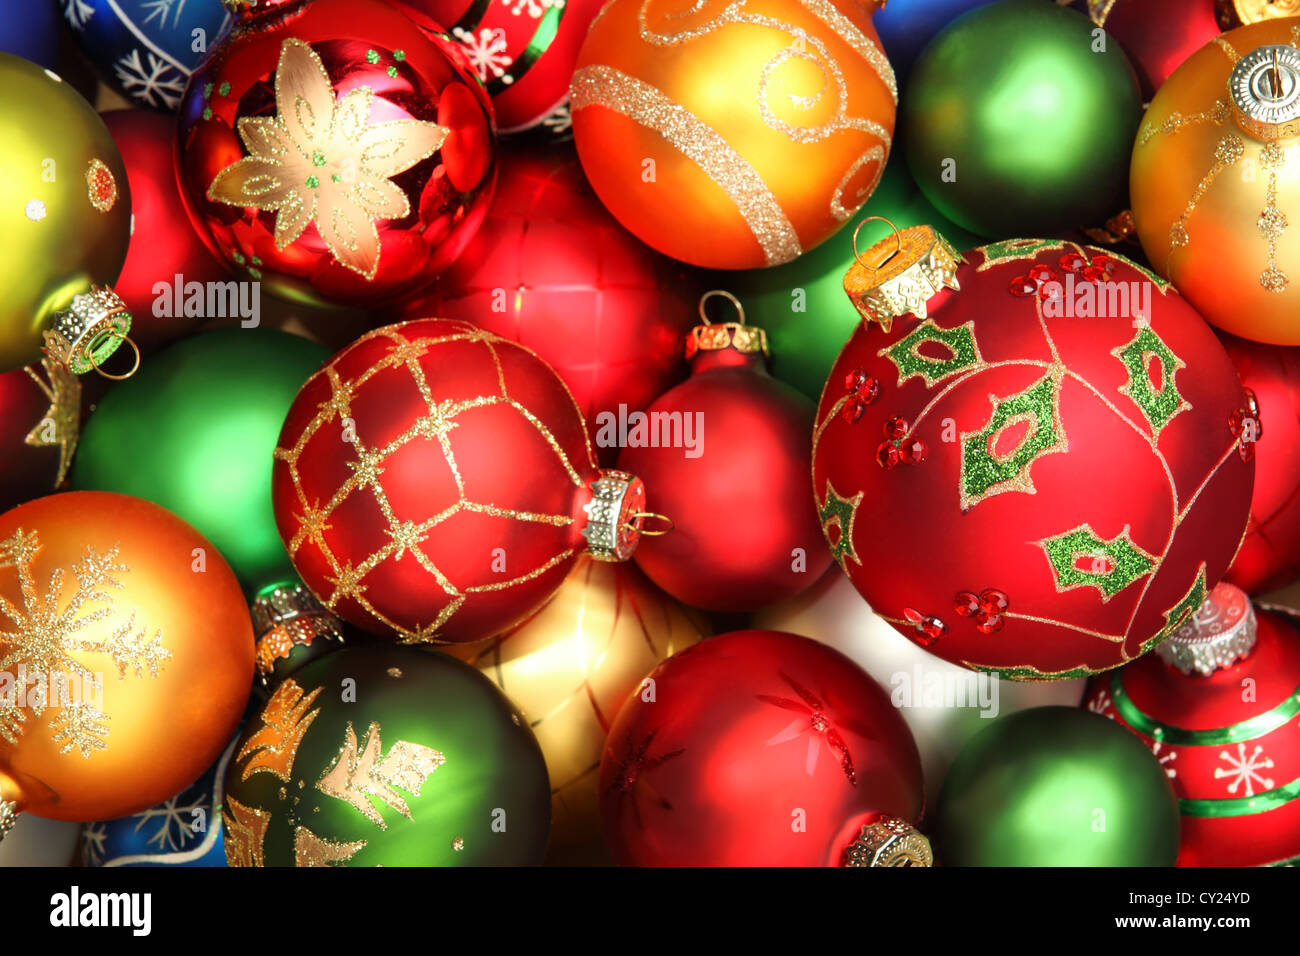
[718,151,982,402]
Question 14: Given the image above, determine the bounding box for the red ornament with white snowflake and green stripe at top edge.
[393,0,603,133]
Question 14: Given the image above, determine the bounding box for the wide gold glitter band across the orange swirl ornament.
[571,66,803,265]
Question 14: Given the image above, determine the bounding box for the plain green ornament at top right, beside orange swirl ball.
[898,0,1141,239]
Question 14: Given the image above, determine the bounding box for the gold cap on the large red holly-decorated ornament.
[844,216,966,332]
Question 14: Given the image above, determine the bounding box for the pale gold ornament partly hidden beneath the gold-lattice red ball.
[443,558,709,864]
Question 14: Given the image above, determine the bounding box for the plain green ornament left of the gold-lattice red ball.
[69,329,330,597]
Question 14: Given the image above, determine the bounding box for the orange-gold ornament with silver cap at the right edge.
[1131,17,1300,345]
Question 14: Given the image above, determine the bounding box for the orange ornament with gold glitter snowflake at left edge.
[0,492,254,838]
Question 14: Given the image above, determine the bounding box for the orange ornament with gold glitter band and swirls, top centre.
[571,0,898,269]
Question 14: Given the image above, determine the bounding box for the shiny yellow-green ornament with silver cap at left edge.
[0,53,131,373]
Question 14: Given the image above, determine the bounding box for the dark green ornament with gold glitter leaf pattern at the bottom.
[222,644,551,866]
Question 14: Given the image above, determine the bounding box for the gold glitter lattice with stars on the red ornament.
[274,320,594,644]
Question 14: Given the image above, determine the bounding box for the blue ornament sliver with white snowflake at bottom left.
[81,734,239,866]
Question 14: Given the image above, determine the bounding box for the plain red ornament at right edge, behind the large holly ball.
[1219,332,1300,594]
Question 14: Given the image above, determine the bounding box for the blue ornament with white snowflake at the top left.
[57,0,230,112]
